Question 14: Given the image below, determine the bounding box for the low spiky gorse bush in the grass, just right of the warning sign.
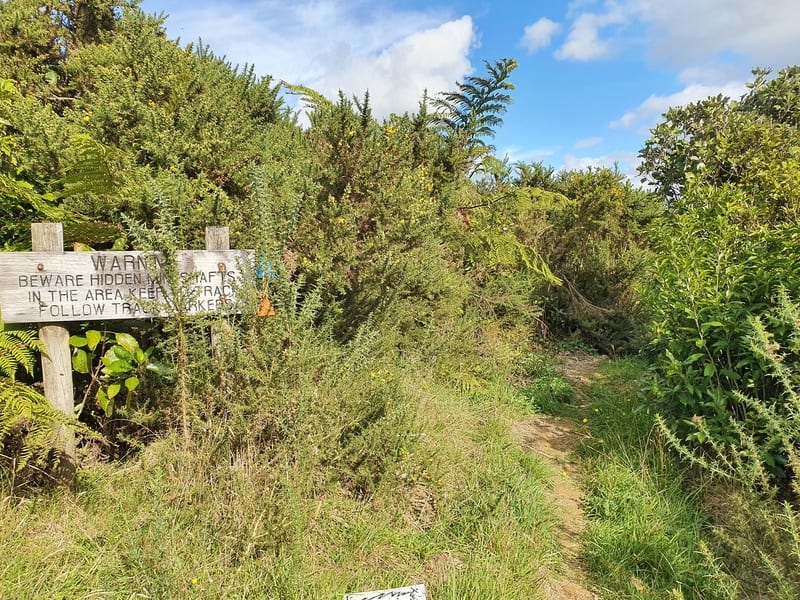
[180,282,414,497]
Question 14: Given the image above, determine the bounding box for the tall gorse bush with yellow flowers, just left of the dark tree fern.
[289,90,468,339]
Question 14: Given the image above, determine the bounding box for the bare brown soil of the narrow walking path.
[514,353,603,600]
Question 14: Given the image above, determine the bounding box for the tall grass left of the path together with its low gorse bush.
[0,302,561,599]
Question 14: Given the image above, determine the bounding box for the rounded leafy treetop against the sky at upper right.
[639,66,800,211]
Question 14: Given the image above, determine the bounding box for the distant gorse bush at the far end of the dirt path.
[514,164,663,354]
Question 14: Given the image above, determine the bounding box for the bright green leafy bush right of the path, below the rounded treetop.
[642,187,800,475]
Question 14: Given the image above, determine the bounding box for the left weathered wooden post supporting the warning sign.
[31,223,77,484]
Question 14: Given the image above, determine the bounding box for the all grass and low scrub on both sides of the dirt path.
[14,312,800,600]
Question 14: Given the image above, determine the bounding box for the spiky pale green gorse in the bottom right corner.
[648,288,800,600]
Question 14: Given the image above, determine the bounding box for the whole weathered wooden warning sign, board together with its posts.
[0,223,254,481]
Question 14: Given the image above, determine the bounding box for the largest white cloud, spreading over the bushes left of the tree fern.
[150,0,477,117]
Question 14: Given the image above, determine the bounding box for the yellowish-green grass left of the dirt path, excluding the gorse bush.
[0,347,561,599]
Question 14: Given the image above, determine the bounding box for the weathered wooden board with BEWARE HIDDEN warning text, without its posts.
[0,250,253,323]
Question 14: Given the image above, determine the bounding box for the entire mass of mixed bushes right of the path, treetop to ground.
[640,66,800,598]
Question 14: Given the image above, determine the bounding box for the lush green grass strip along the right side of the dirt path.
[580,360,737,599]
